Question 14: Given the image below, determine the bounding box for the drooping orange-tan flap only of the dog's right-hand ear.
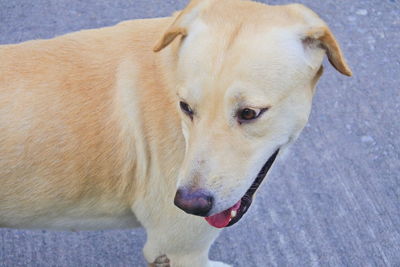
[302,26,352,76]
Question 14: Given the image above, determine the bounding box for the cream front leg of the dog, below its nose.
[135,201,229,267]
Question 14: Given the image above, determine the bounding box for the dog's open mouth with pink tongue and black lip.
[205,149,279,228]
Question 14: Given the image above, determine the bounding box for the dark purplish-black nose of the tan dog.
[174,188,213,217]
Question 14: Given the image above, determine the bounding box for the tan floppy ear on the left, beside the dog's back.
[153,0,214,52]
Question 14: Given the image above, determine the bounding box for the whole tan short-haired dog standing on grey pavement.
[0,0,351,266]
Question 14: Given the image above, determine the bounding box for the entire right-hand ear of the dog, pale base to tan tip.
[291,4,352,76]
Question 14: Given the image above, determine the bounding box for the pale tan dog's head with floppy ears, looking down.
[154,0,351,227]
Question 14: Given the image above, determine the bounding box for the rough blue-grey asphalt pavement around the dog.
[0,0,400,267]
